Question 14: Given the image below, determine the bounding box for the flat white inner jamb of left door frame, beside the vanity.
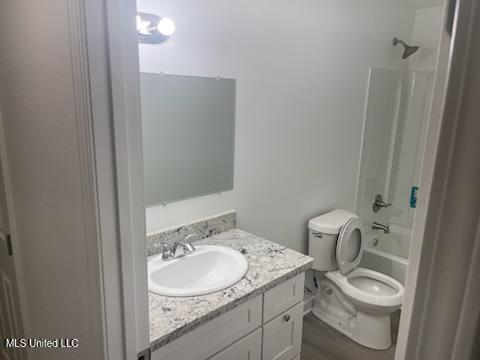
[103,0,150,358]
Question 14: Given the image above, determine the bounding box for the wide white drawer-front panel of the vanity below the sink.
[152,296,262,360]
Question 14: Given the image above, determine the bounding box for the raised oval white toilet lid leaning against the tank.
[336,218,364,275]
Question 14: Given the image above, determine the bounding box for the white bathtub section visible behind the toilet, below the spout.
[360,225,410,284]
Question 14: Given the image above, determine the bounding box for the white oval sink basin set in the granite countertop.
[148,245,248,296]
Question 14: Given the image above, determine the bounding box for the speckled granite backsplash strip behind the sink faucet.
[147,210,237,256]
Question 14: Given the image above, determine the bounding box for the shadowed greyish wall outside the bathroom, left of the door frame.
[0,0,103,360]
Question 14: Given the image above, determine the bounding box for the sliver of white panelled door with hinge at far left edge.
[0,113,23,360]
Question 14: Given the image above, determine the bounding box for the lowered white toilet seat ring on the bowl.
[326,268,405,307]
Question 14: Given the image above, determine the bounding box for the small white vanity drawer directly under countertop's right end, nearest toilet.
[263,273,305,324]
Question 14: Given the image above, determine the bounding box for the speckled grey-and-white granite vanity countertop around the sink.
[149,229,313,351]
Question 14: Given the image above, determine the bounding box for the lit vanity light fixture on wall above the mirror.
[136,13,175,44]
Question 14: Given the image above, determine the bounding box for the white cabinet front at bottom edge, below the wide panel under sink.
[210,329,262,360]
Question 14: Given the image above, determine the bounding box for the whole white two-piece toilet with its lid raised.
[308,209,405,350]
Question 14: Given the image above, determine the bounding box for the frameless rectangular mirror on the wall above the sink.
[140,73,235,206]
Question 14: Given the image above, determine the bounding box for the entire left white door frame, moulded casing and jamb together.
[82,0,150,360]
